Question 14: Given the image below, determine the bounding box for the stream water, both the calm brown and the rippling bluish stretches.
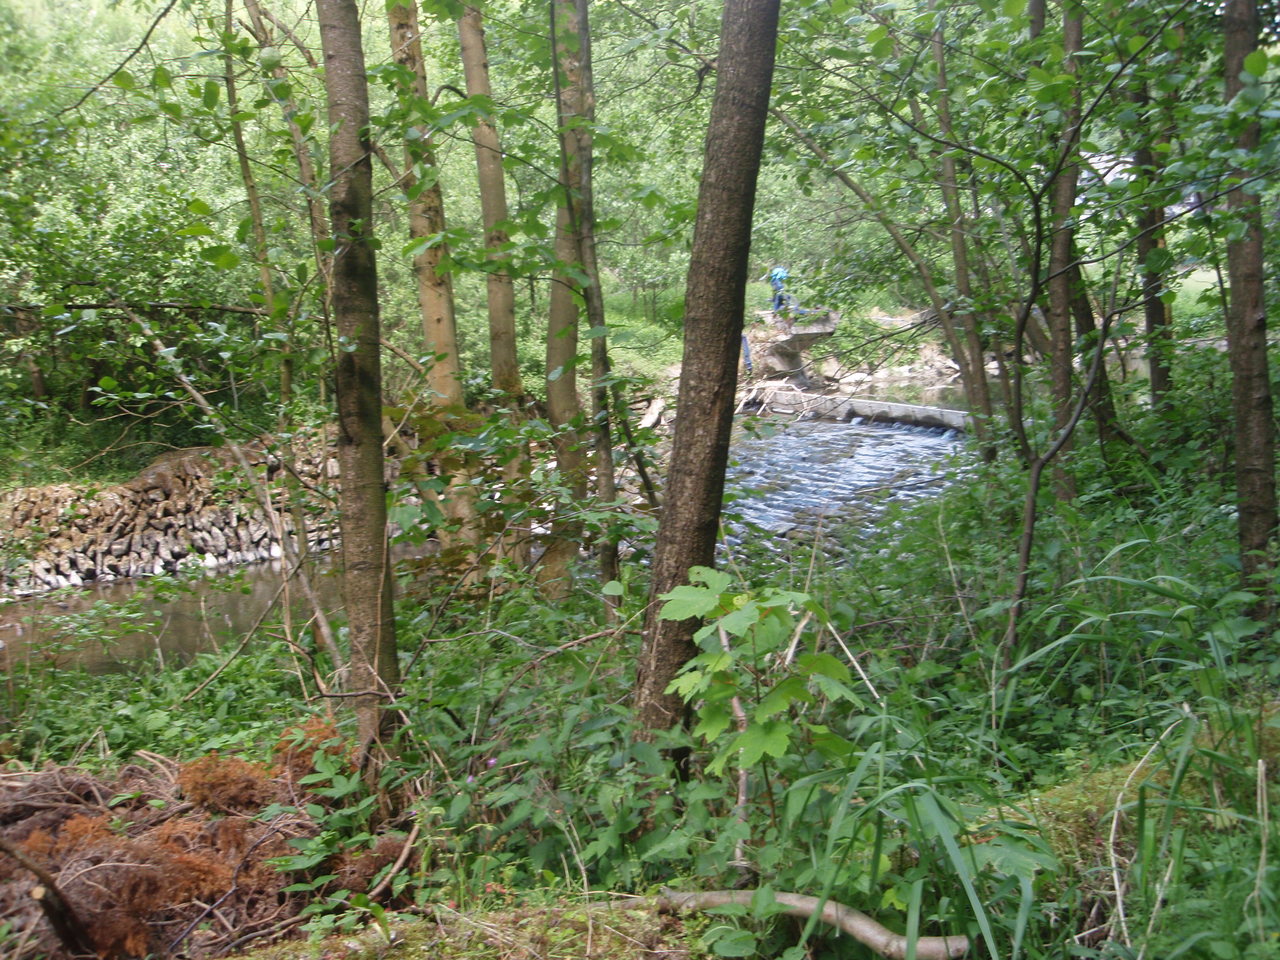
[0,419,960,672]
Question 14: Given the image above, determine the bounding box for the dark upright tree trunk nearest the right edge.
[1222,0,1276,586]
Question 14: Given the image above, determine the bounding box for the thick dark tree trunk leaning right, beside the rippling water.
[634,0,778,731]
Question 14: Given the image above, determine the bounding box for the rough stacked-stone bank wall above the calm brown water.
[0,444,338,596]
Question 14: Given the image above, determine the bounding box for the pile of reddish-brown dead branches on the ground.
[0,727,404,960]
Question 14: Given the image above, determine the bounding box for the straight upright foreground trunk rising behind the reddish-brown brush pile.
[316,0,399,772]
